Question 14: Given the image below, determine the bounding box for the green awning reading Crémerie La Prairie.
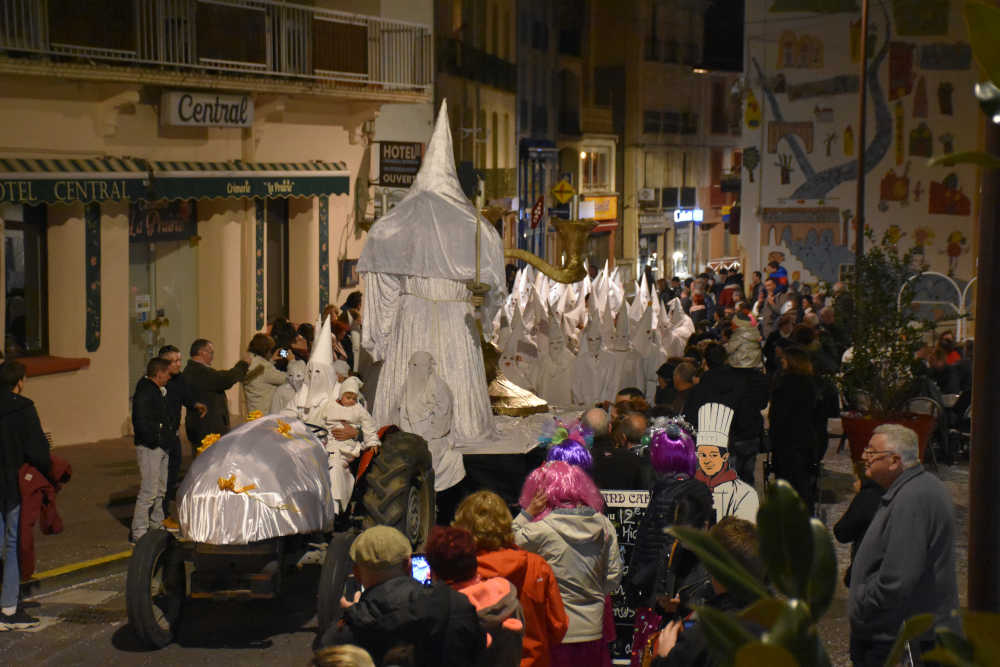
[150,161,351,199]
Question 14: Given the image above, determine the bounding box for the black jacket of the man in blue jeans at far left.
[0,391,50,512]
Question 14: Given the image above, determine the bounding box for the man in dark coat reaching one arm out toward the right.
[184,338,249,450]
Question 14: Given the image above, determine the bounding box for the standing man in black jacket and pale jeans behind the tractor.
[129,357,177,543]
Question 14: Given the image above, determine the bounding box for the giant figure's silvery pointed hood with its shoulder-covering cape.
[358,102,507,304]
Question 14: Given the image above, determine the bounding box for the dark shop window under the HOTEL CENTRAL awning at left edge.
[0,205,49,357]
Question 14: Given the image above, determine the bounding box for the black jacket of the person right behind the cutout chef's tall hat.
[684,366,768,442]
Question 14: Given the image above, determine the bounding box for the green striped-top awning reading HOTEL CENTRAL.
[0,157,149,204]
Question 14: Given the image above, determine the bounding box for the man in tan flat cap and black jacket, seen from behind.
[320,526,486,667]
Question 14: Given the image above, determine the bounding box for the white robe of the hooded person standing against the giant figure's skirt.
[399,374,465,491]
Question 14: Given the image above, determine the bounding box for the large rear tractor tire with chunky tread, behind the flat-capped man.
[361,432,436,548]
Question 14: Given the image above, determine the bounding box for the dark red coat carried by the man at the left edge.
[18,454,73,581]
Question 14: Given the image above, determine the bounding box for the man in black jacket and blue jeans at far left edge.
[0,361,49,630]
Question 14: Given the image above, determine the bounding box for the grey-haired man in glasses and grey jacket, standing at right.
[848,424,958,667]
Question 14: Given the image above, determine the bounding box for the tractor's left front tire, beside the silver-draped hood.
[125,530,186,649]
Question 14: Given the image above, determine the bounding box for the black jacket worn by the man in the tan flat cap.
[320,576,486,667]
